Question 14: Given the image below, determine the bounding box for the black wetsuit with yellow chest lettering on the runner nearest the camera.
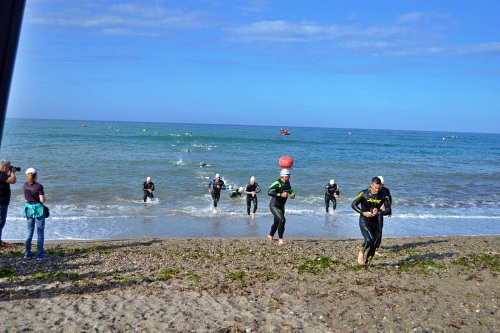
[351,188,391,264]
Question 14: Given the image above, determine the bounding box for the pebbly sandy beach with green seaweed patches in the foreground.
[0,236,500,332]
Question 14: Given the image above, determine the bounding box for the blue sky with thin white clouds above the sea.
[7,0,500,133]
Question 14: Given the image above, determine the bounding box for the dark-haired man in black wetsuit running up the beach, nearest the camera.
[351,177,391,265]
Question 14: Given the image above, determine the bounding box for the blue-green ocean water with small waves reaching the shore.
[0,119,500,240]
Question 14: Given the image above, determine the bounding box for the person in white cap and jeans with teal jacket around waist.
[23,168,50,260]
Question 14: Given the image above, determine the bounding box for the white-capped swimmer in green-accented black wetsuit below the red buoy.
[267,169,295,245]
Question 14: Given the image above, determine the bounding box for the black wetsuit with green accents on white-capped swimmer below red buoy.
[267,179,295,239]
